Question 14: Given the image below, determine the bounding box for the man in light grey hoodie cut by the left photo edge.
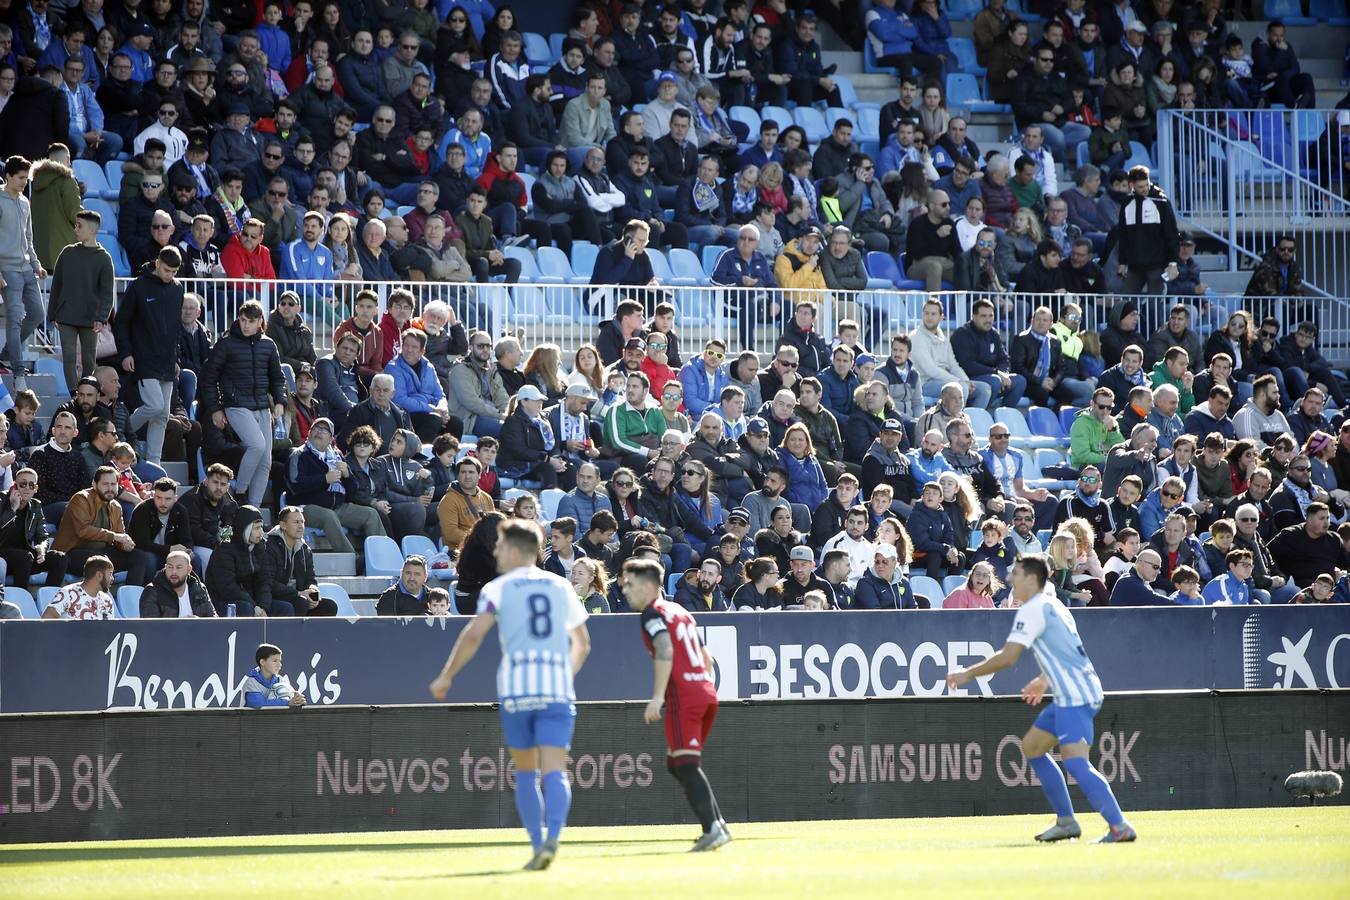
[0,157,47,372]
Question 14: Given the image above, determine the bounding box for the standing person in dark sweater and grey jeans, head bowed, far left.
[47,209,116,385]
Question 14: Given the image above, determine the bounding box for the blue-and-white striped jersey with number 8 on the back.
[478,565,590,712]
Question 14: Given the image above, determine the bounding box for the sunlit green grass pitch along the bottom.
[0,807,1350,900]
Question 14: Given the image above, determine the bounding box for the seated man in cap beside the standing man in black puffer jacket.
[286,418,385,553]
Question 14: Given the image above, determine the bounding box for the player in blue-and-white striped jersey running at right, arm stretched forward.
[946,553,1135,843]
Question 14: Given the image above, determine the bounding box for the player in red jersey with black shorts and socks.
[621,560,732,853]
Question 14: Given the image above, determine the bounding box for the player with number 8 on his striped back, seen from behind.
[431,519,590,869]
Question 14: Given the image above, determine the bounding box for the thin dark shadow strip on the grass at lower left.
[0,835,671,863]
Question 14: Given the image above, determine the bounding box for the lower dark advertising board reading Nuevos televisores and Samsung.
[0,691,1350,843]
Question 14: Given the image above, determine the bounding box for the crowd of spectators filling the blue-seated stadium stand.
[0,0,1350,617]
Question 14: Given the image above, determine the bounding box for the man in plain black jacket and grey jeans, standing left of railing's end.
[113,247,182,466]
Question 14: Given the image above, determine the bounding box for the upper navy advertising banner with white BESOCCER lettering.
[0,606,1350,712]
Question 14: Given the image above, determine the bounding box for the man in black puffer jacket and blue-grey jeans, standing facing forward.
[197,300,286,507]
